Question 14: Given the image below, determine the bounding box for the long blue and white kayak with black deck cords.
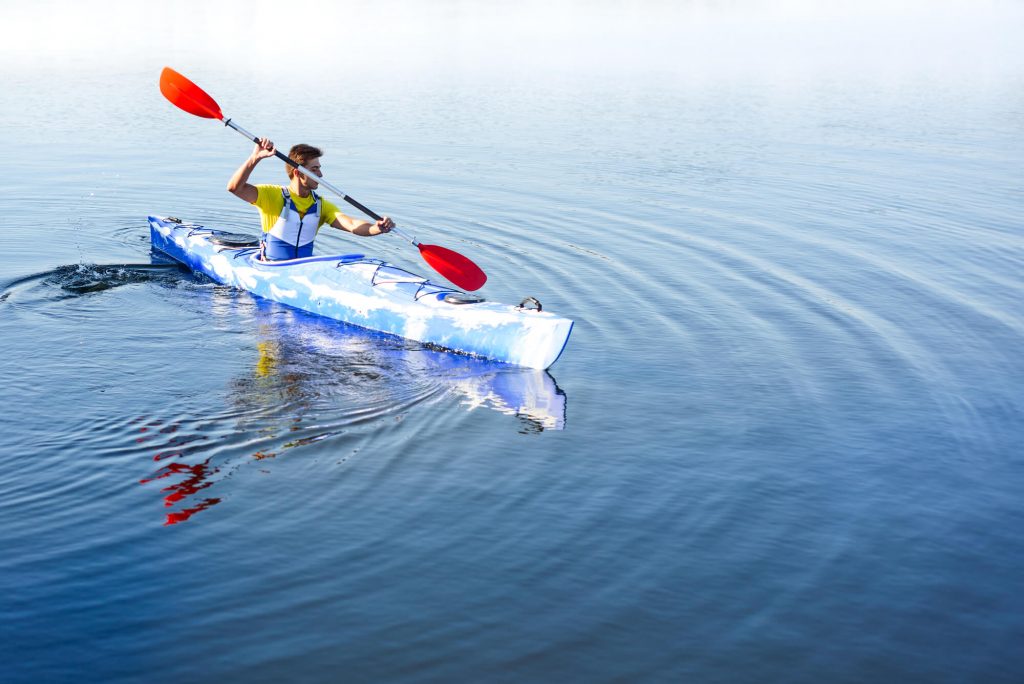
[150,216,572,370]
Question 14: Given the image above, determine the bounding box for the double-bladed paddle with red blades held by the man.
[160,67,487,291]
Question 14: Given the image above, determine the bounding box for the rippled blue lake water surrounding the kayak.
[0,3,1024,682]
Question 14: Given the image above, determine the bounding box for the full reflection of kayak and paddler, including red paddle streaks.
[142,288,566,525]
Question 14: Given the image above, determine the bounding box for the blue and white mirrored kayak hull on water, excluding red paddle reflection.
[230,301,566,432]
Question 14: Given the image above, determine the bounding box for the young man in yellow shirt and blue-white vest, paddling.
[227,138,394,261]
